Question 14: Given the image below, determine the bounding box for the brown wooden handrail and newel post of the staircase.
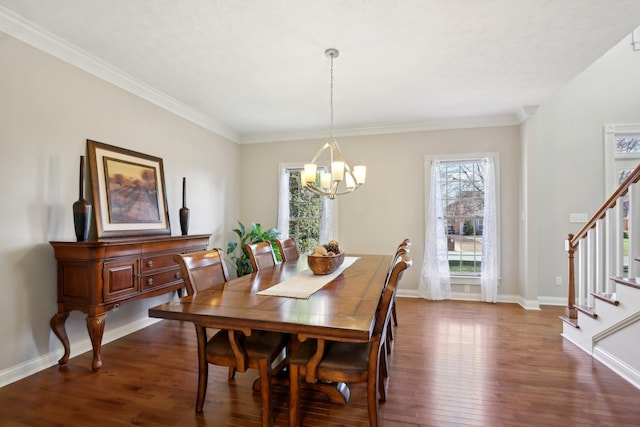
[565,164,640,319]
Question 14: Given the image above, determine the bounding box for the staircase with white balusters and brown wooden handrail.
[561,165,640,388]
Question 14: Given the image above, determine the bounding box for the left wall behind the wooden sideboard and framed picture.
[0,33,239,384]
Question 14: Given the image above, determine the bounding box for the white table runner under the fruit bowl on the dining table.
[257,257,360,299]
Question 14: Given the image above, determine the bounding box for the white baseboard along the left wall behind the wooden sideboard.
[0,317,162,387]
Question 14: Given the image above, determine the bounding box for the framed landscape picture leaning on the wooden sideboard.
[87,139,171,238]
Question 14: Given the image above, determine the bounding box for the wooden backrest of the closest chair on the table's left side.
[173,249,229,295]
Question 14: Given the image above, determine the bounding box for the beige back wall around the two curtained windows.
[240,126,520,301]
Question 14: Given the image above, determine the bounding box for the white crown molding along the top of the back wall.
[239,114,522,144]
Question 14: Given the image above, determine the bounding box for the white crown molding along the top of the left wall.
[0,6,240,142]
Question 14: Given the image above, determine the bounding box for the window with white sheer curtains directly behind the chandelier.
[278,165,336,253]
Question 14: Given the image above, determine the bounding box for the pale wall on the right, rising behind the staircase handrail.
[531,33,640,299]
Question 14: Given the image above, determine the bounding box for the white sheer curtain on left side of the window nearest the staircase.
[418,160,451,300]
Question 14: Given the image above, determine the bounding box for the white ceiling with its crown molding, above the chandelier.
[0,0,640,142]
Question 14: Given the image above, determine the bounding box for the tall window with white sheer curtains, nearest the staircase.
[423,153,500,302]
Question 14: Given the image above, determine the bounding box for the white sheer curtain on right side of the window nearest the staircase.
[480,157,499,302]
